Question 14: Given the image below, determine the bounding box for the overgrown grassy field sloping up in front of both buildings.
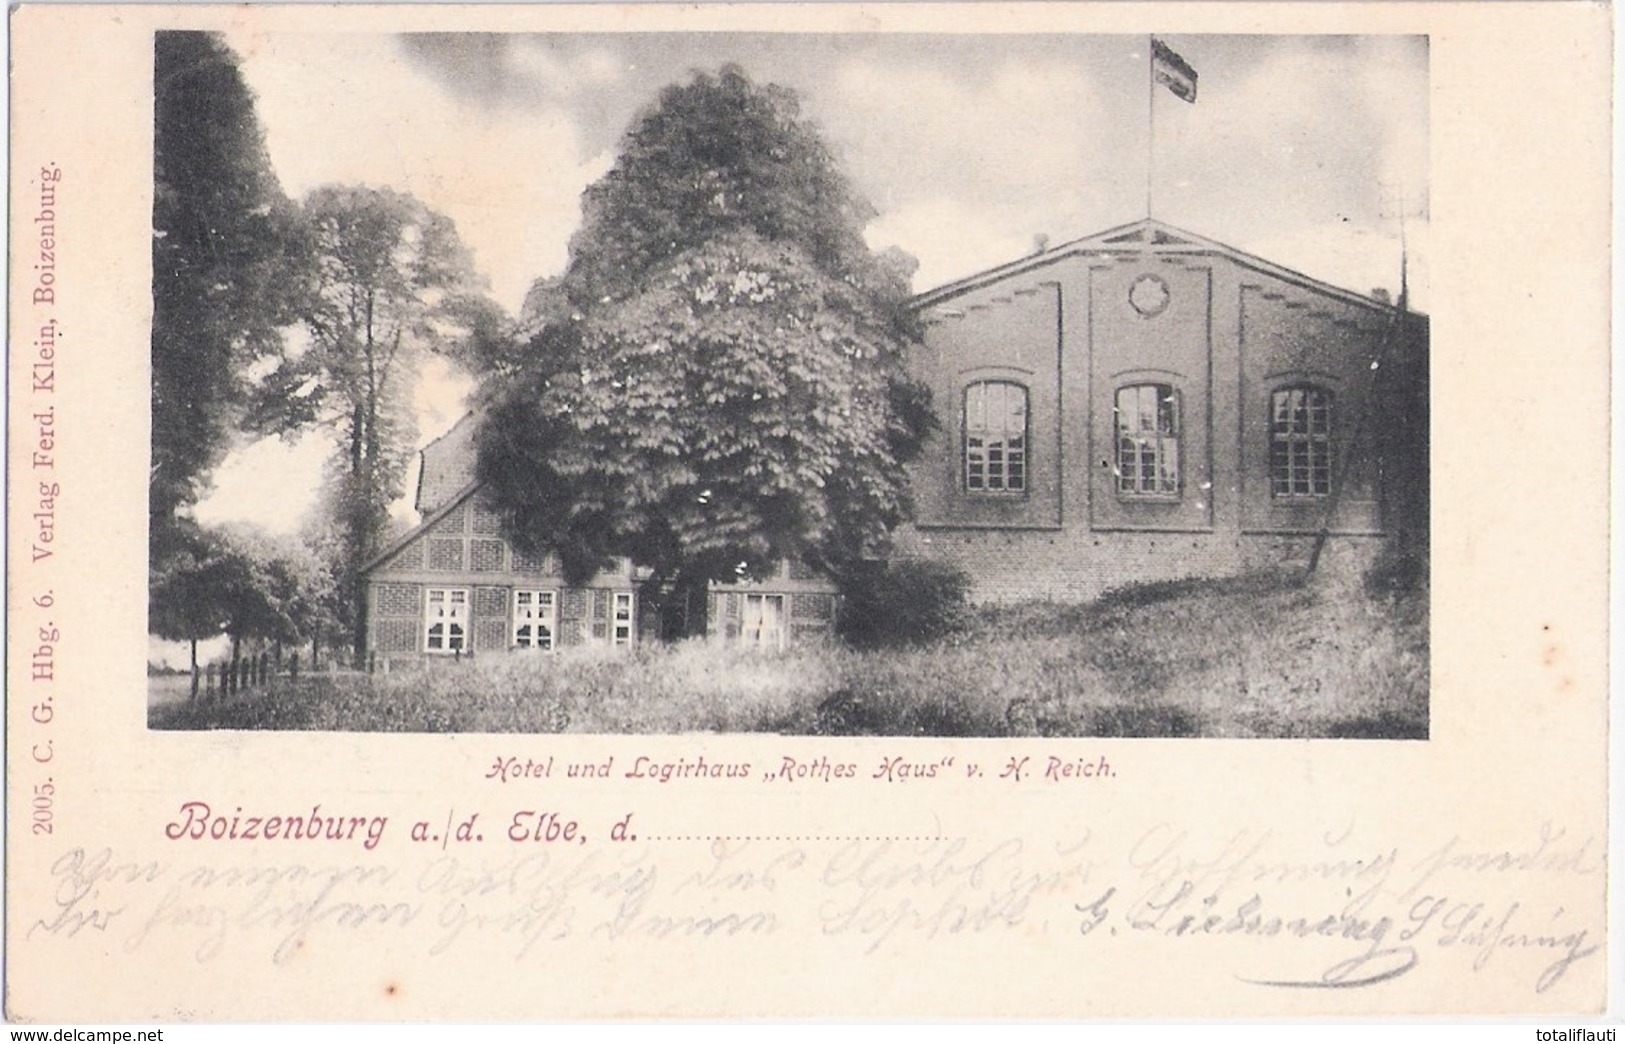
[150,574,1428,738]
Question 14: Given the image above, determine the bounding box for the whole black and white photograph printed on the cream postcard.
[150,31,1428,740]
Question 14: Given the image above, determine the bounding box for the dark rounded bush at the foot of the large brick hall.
[839,559,970,649]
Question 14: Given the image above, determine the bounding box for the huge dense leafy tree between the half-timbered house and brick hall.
[479,68,934,624]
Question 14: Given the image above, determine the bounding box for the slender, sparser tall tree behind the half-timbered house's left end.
[254,185,497,641]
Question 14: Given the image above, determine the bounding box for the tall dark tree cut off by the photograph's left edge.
[148,31,306,552]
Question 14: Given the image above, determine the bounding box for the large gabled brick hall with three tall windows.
[899,220,1428,600]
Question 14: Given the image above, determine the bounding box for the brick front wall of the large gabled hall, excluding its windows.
[897,241,1428,602]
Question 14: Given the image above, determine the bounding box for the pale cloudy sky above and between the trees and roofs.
[197,33,1428,532]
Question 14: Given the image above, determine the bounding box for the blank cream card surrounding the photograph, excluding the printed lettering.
[7,3,1610,1021]
